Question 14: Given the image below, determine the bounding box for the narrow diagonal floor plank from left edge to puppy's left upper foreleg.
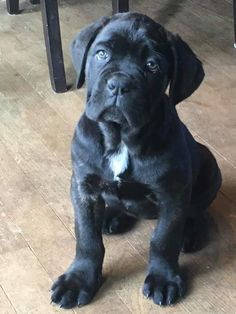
[0,79,73,233]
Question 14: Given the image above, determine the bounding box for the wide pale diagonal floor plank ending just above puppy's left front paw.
[0,142,75,278]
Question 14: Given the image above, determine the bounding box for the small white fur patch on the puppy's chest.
[109,144,129,181]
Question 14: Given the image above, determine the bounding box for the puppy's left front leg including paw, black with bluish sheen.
[51,176,104,309]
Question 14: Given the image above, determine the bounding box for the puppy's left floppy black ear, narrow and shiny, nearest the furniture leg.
[71,17,111,88]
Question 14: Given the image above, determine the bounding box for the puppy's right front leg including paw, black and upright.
[143,196,187,305]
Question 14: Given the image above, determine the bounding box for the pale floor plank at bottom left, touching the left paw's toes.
[0,248,72,314]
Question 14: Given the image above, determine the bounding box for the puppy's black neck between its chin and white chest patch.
[99,97,177,155]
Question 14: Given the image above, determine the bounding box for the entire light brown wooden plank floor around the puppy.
[0,0,236,314]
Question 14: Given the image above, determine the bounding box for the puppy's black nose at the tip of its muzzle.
[107,75,131,95]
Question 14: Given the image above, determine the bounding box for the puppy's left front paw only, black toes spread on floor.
[51,271,101,309]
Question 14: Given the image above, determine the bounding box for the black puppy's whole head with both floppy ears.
[72,13,204,127]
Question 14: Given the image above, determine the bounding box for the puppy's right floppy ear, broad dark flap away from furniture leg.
[167,32,205,105]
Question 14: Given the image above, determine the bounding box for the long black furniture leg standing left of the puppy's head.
[41,0,67,93]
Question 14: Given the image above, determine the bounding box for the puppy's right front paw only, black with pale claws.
[143,273,184,306]
